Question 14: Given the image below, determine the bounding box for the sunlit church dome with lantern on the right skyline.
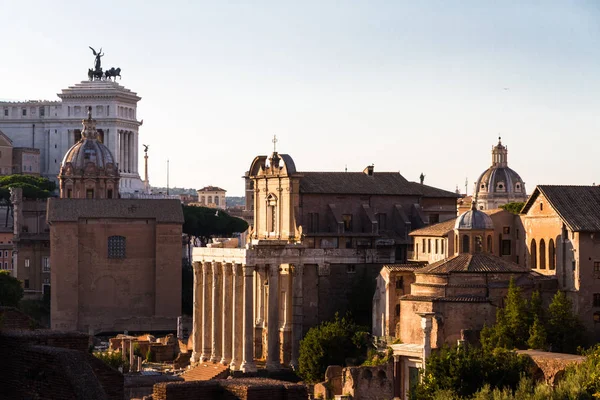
[475,138,527,209]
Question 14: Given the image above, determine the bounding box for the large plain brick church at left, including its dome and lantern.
[47,110,183,334]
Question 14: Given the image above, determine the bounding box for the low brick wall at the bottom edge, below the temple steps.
[152,378,308,400]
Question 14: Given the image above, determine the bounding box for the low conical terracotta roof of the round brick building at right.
[416,253,528,274]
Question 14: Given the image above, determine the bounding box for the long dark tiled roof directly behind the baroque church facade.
[300,172,458,197]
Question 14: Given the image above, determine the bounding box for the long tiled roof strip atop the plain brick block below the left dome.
[46,198,183,224]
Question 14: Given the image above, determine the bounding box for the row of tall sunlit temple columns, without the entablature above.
[192,262,303,372]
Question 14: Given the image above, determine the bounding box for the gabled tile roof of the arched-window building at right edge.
[521,185,600,232]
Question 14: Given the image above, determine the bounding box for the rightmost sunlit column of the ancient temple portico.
[278,264,292,365]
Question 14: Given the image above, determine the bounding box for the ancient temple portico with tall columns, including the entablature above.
[192,240,393,372]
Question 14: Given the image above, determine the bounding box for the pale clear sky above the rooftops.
[0,0,600,196]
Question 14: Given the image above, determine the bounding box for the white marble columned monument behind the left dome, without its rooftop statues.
[0,80,144,193]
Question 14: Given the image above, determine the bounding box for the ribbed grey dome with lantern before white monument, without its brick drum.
[61,107,116,175]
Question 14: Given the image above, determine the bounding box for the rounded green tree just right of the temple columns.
[298,314,368,383]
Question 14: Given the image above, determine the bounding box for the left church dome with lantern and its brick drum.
[58,107,120,199]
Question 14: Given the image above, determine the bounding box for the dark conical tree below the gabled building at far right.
[547,291,584,353]
